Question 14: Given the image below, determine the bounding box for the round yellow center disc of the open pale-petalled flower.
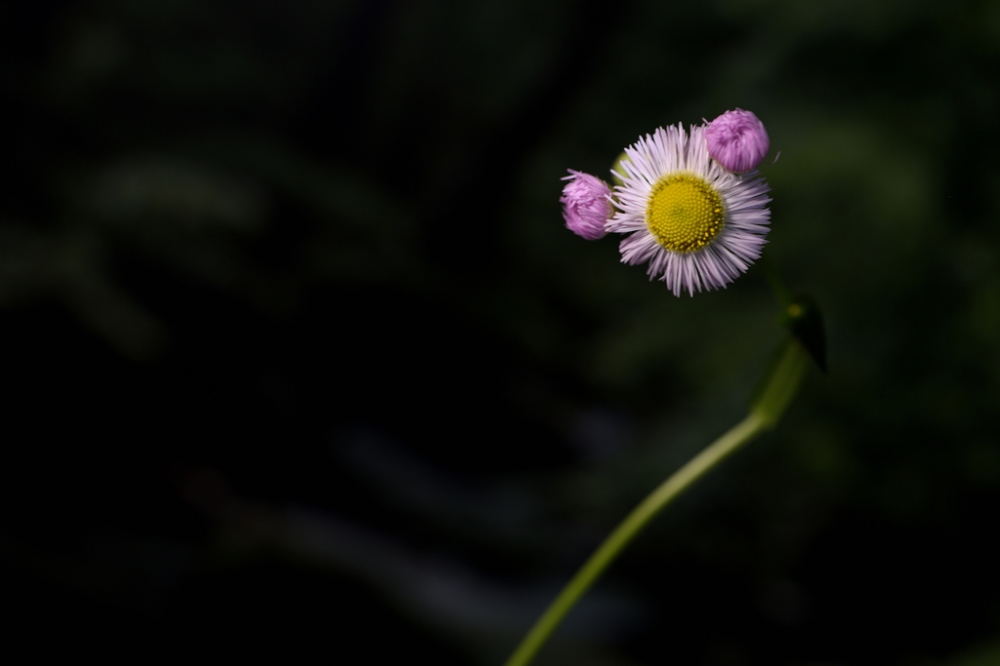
[646,173,726,252]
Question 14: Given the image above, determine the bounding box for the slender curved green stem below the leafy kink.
[506,410,773,666]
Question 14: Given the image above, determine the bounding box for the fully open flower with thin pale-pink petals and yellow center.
[606,125,771,296]
